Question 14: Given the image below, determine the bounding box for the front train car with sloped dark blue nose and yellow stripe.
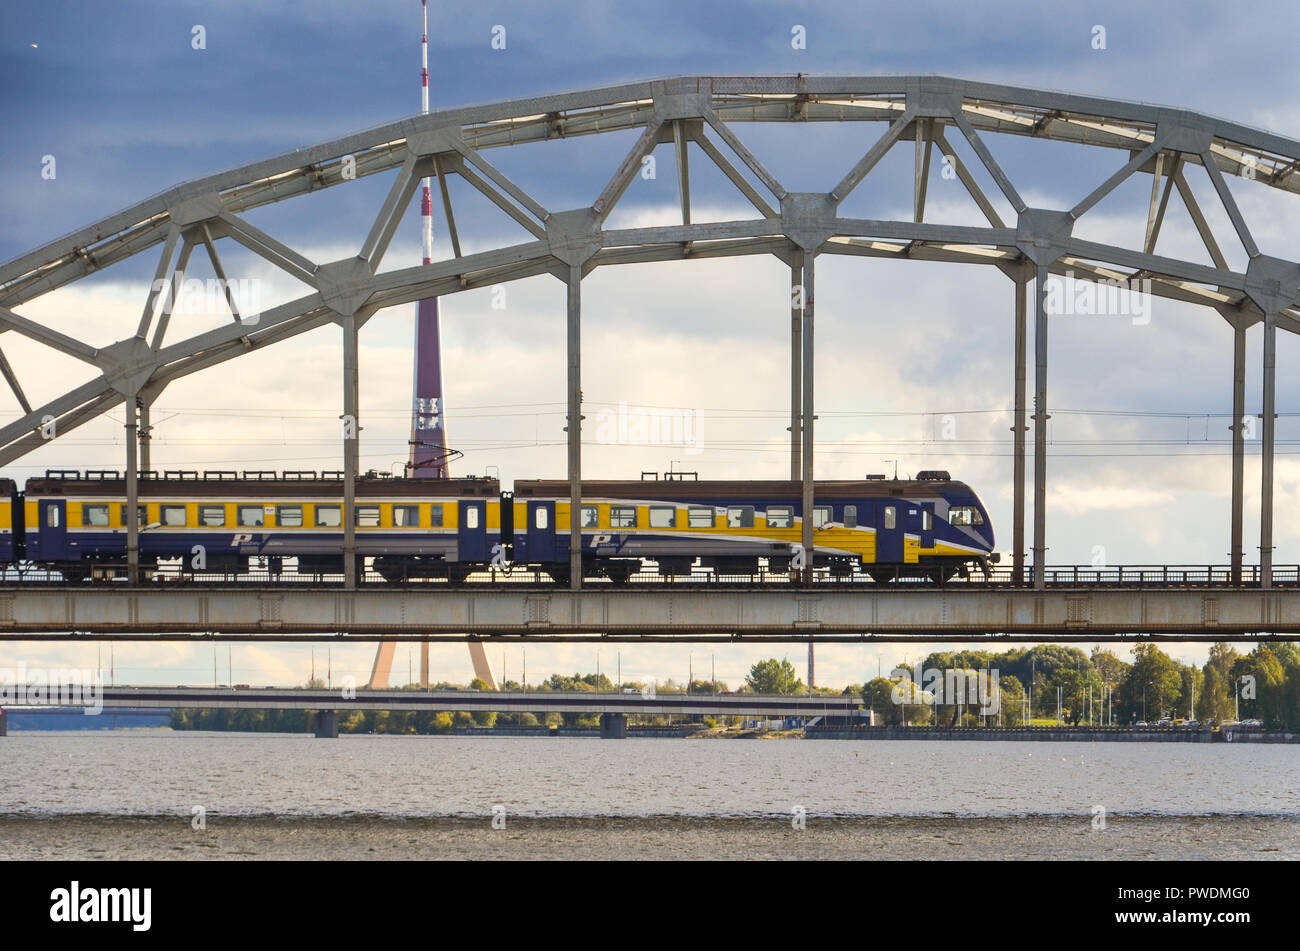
[514,472,997,581]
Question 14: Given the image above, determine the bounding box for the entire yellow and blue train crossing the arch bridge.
[0,470,997,582]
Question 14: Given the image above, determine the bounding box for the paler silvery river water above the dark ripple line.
[0,733,1300,818]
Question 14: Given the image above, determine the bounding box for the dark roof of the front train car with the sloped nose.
[515,478,974,501]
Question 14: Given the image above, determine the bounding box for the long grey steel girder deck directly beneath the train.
[0,585,1300,642]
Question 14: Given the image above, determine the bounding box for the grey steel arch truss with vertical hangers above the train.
[0,75,1300,587]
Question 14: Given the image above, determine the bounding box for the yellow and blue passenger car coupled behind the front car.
[23,470,501,581]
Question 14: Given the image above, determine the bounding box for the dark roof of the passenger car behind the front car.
[26,469,501,499]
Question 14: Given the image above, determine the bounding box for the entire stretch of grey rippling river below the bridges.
[0,731,1300,859]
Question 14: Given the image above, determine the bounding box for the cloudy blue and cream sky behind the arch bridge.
[0,0,1300,686]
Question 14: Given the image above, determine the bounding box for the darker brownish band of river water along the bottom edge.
[0,813,1300,860]
